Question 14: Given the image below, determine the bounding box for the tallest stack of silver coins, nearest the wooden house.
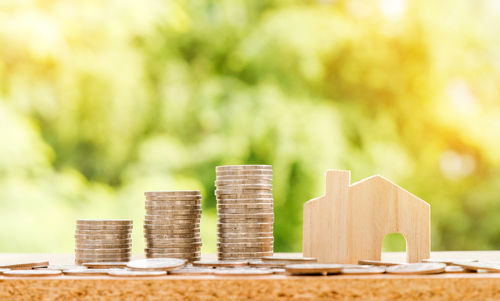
[215,165,274,260]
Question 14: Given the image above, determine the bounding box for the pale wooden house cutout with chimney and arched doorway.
[303,170,430,263]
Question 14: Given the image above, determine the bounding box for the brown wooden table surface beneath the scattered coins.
[0,251,500,300]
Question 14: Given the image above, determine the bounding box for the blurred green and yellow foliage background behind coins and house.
[0,0,500,252]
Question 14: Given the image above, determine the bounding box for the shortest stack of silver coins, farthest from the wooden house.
[75,219,132,264]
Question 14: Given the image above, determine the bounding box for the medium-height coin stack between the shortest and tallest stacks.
[144,190,201,261]
